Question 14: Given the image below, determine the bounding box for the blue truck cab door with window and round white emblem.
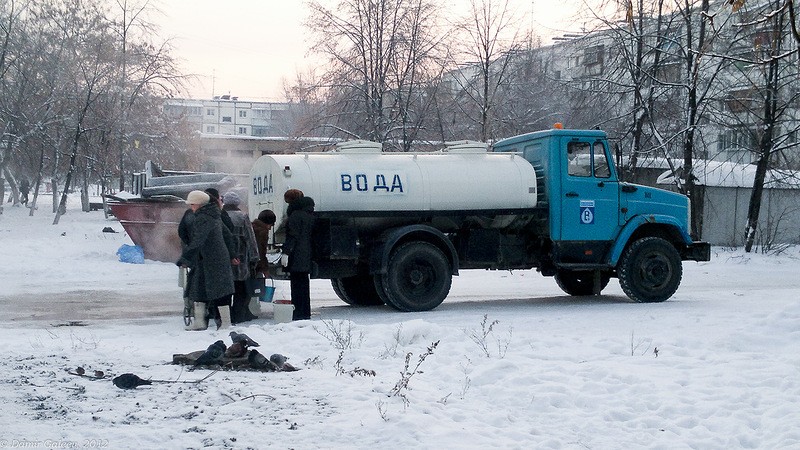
[559,138,619,253]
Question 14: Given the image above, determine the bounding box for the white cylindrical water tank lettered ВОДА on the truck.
[248,141,536,232]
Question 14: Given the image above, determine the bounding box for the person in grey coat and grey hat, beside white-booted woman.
[222,191,258,324]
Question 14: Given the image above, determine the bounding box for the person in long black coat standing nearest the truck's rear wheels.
[281,189,314,320]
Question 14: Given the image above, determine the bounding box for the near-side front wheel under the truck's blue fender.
[617,237,683,303]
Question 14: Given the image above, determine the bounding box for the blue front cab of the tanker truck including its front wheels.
[492,128,710,302]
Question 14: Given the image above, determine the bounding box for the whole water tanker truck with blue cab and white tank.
[248,128,710,311]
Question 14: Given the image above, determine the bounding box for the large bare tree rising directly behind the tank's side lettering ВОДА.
[308,0,444,148]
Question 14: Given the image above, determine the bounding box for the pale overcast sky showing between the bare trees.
[150,0,577,101]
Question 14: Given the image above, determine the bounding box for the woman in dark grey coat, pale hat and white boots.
[176,191,238,330]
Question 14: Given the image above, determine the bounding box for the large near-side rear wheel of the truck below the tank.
[380,242,453,312]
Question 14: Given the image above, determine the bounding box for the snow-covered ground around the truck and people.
[0,202,800,449]
